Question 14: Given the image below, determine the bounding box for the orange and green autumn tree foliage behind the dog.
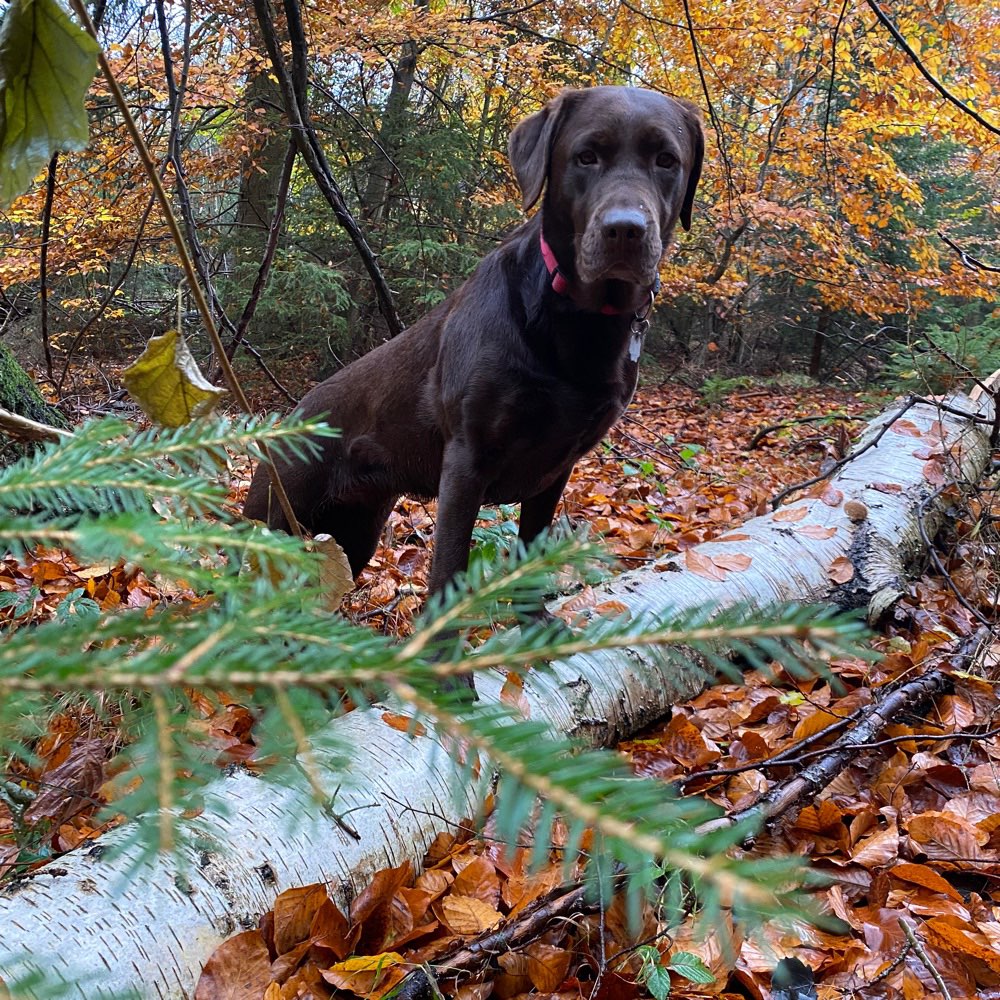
[0,0,1000,375]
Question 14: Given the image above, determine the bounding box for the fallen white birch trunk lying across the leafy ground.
[0,396,992,1000]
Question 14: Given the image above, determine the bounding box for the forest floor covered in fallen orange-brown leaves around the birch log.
[0,374,1000,1000]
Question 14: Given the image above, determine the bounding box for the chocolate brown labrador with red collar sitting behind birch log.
[244,87,704,616]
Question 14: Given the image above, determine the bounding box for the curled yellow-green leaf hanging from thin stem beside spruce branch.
[122,330,226,427]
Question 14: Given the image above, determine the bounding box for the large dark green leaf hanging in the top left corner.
[0,0,98,207]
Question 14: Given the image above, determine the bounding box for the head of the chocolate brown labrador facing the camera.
[510,87,705,304]
